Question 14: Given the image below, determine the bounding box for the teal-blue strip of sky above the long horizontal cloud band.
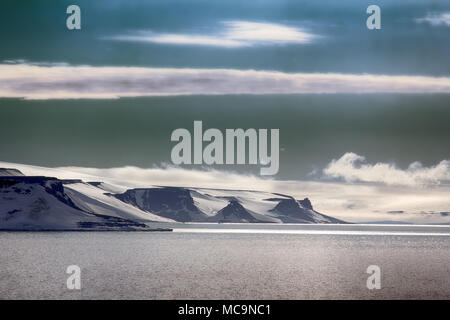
[0,0,450,76]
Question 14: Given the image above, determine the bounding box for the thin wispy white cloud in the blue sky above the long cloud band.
[104,21,316,48]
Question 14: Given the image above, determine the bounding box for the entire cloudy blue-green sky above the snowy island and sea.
[0,0,450,222]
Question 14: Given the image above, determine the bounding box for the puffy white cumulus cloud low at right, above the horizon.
[323,152,450,186]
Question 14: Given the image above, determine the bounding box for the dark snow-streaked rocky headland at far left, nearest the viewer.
[0,176,150,231]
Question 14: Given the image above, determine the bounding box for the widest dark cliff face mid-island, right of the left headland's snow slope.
[114,187,207,222]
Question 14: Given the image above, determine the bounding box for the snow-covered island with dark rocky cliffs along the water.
[0,168,345,231]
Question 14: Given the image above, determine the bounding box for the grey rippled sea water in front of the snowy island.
[0,225,450,299]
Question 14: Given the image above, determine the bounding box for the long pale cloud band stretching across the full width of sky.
[0,63,450,99]
